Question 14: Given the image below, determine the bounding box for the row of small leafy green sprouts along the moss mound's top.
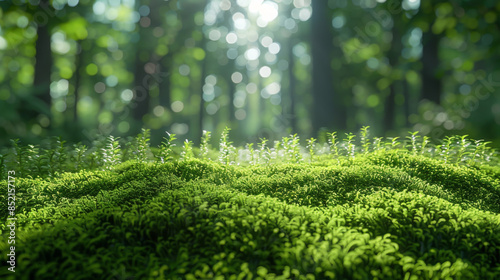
[0,126,499,179]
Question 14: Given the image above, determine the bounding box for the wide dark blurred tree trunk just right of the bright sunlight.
[311,1,346,133]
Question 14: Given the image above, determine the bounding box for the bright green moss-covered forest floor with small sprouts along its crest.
[0,130,500,279]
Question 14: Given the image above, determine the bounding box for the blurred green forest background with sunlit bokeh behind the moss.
[0,0,500,146]
